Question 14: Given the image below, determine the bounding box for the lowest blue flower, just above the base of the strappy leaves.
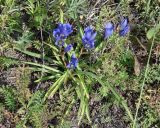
[67,54,78,69]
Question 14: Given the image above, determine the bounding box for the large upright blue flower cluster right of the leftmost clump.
[82,26,97,49]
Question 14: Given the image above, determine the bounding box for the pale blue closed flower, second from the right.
[104,22,114,39]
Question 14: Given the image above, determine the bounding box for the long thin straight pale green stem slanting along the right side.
[133,37,155,128]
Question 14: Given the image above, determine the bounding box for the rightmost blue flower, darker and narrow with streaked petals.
[119,18,130,36]
